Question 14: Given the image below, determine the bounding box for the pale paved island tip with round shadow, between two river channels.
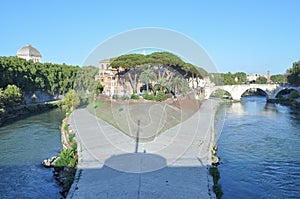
[68,100,218,198]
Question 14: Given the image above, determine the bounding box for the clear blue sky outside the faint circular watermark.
[0,0,300,74]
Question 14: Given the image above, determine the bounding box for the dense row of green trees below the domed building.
[0,57,79,94]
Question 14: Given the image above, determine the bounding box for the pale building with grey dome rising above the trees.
[17,44,42,63]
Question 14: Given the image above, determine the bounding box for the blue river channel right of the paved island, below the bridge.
[216,96,300,199]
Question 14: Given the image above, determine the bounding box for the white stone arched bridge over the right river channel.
[205,84,300,101]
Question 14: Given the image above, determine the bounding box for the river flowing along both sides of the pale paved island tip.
[0,97,300,199]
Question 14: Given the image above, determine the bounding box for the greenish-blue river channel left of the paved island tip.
[0,109,64,198]
